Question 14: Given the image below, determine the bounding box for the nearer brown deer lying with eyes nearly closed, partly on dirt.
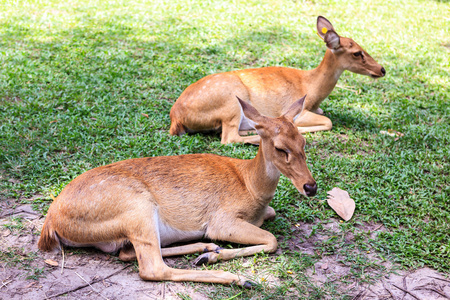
[38,97,317,287]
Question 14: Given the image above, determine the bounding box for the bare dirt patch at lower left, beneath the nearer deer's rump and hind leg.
[0,205,211,300]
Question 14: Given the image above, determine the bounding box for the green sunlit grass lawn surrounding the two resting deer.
[0,0,450,299]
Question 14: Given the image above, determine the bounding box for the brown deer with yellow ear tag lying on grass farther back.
[170,16,386,144]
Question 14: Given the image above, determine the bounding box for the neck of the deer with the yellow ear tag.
[305,49,344,110]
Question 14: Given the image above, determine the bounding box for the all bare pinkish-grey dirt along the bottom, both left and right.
[0,205,450,300]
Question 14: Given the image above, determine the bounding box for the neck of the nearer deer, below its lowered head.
[244,140,280,205]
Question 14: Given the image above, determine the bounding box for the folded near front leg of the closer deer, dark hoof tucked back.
[194,220,278,265]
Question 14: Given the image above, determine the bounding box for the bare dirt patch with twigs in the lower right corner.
[287,219,450,300]
